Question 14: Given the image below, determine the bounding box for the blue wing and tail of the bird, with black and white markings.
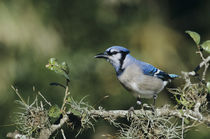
[140,61,178,81]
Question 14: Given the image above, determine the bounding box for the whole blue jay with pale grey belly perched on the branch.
[95,46,178,105]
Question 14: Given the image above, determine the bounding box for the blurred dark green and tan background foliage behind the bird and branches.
[0,0,210,139]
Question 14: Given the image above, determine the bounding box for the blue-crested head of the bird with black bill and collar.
[95,46,130,72]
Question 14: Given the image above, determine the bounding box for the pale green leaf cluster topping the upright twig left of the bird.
[45,58,70,80]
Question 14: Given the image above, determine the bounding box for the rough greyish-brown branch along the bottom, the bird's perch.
[7,104,210,139]
